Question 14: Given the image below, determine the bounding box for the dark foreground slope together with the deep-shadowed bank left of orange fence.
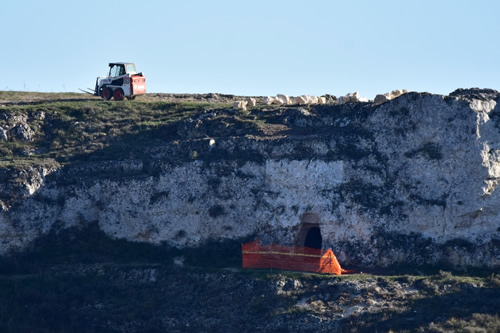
[0,223,500,333]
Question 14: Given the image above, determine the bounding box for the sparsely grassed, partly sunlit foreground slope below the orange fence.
[0,264,500,333]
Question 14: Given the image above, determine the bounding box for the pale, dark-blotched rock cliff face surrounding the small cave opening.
[0,90,500,267]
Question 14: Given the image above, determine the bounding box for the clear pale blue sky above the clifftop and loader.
[0,0,500,98]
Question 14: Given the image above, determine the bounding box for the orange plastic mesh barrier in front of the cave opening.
[241,240,354,275]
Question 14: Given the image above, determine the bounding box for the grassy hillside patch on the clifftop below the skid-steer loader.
[0,91,294,170]
